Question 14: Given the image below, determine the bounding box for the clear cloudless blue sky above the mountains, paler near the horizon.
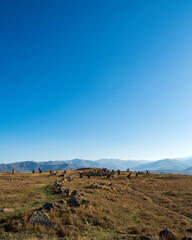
[0,0,192,163]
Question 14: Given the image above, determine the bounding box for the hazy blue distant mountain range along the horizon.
[0,157,192,175]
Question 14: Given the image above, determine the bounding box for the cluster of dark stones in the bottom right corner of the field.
[141,228,192,240]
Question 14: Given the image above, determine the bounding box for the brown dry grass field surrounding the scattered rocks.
[0,171,192,240]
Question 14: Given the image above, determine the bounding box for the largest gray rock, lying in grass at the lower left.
[28,211,56,227]
